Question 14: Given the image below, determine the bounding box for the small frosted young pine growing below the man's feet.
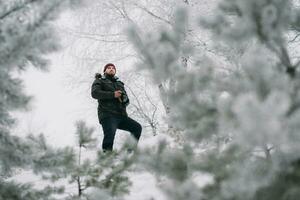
[61,121,135,199]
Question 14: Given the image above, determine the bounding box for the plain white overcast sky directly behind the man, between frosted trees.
[13,5,162,152]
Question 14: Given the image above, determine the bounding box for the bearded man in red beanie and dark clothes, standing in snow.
[91,63,142,152]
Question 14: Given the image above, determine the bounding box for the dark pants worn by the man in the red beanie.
[101,116,142,151]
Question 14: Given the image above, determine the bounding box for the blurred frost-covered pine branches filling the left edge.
[0,0,80,200]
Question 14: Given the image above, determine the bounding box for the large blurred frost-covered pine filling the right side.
[129,0,300,200]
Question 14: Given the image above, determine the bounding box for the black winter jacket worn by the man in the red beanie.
[91,75,129,123]
